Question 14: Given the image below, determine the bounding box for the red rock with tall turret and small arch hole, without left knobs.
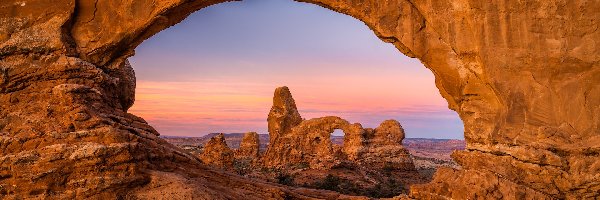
[262,87,415,170]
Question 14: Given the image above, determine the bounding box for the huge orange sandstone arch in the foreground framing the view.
[0,0,600,199]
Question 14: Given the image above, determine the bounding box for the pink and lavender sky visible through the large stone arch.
[130,0,463,139]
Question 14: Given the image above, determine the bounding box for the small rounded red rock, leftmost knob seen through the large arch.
[199,133,234,168]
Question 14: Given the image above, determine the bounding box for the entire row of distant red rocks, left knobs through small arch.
[200,86,415,171]
